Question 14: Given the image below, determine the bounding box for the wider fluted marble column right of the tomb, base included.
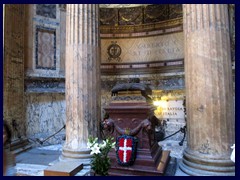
[180,4,235,176]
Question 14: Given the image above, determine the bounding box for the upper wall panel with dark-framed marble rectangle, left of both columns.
[25,4,65,78]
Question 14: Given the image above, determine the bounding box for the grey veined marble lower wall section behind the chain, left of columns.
[25,93,66,144]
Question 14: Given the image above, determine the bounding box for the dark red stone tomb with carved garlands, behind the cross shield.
[104,80,170,176]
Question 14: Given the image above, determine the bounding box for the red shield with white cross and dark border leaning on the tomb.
[116,135,137,166]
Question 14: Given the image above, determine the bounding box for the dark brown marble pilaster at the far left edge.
[3,4,26,141]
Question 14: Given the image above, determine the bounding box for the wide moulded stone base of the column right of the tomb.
[179,150,235,176]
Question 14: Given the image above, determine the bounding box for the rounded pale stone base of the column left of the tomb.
[59,149,92,166]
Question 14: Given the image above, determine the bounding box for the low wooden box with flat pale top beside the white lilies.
[44,161,83,176]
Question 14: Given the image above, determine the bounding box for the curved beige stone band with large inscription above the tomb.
[101,32,184,63]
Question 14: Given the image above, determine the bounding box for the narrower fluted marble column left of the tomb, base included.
[60,4,100,165]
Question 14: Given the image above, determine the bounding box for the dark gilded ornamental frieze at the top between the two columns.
[100,4,182,34]
